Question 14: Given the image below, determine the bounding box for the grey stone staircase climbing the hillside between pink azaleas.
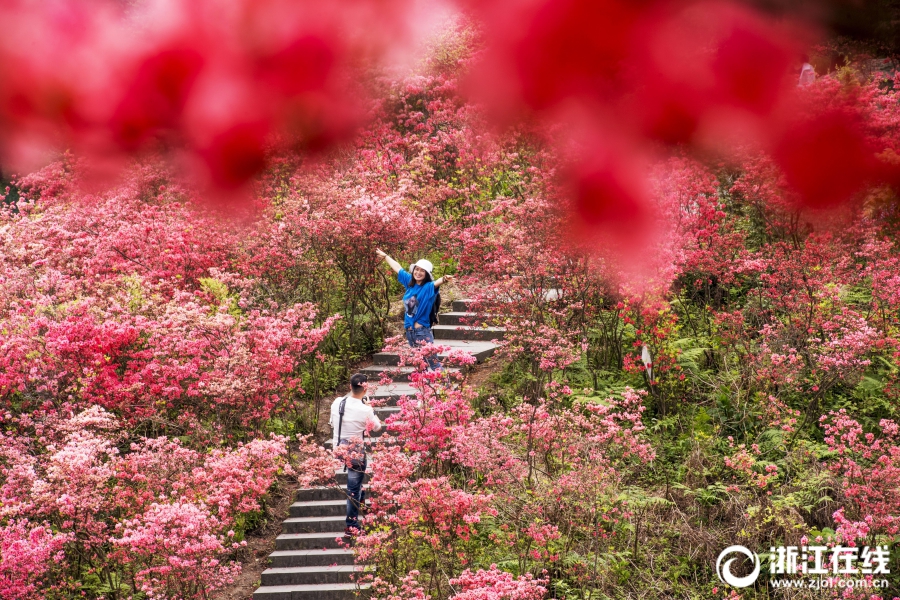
[253,300,505,600]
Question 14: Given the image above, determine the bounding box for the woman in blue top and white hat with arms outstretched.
[375,250,454,371]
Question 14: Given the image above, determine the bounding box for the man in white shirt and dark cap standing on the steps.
[328,373,381,536]
